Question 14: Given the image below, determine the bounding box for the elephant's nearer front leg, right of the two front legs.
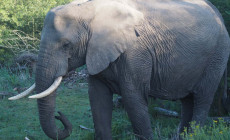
[122,83,153,140]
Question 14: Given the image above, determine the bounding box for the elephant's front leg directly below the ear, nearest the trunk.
[89,76,113,140]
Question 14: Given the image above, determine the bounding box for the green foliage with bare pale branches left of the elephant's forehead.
[0,0,72,65]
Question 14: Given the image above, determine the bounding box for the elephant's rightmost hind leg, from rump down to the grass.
[192,31,230,125]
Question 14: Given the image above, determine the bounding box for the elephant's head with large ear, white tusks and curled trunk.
[10,2,142,139]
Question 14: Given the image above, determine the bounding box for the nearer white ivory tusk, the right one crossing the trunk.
[29,76,62,99]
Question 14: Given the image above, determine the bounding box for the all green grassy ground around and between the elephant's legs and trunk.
[0,69,230,140]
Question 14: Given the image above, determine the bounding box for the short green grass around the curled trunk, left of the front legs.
[0,81,93,140]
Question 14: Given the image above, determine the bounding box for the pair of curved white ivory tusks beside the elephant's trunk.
[9,76,63,100]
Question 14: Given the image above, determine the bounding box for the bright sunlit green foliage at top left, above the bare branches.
[0,0,71,38]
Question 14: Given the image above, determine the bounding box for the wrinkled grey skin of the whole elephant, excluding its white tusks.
[36,0,230,140]
